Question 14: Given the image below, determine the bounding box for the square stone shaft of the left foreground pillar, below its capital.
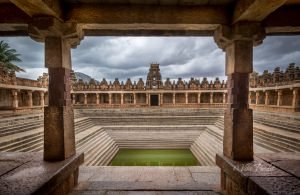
[44,37,75,161]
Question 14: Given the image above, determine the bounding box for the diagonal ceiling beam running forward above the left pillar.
[10,0,63,20]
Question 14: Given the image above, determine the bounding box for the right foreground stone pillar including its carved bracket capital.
[214,22,264,161]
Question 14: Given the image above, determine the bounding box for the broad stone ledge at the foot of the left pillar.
[0,152,84,195]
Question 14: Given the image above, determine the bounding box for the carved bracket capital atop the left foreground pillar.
[28,16,83,48]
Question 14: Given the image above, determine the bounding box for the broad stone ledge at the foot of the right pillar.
[216,153,300,195]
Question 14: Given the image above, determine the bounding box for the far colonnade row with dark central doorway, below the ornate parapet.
[72,90,227,108]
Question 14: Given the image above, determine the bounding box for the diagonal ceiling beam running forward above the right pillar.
[232,0,287,23]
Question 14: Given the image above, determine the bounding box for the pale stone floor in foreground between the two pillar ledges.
[72,166,220,195]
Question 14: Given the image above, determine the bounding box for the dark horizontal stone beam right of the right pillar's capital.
[263,6,300,35]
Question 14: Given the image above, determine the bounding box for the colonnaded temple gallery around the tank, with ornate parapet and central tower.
[0,63,300,113]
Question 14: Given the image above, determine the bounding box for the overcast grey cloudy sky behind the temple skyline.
[0,36,300,80]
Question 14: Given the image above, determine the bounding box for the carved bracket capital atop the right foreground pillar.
[214,21,265,51]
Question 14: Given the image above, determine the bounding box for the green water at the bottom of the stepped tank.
[111,149,199,166]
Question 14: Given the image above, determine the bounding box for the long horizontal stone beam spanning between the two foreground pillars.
[66,5,229,31]
